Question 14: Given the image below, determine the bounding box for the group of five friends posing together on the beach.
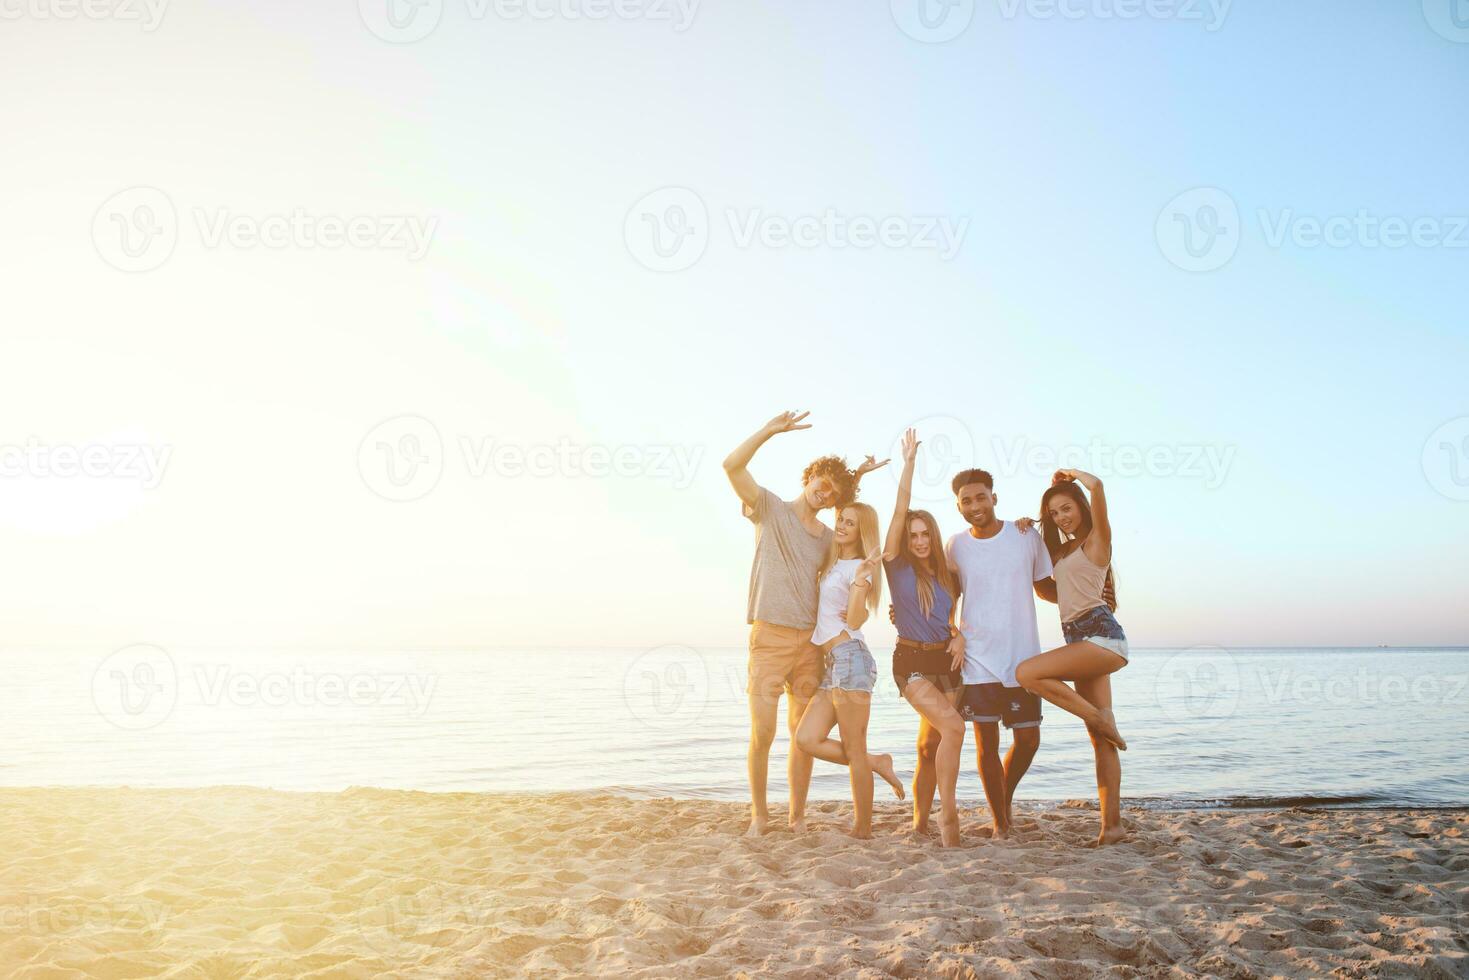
[724,411,1128,846]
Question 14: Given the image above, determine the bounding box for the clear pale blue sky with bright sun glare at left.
[0,0,1469,658]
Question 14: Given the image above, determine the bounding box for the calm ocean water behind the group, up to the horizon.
[0,646,1469,807]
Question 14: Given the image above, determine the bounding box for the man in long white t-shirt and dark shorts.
[945,470,1056,837]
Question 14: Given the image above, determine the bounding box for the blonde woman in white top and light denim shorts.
[796,504,903,839]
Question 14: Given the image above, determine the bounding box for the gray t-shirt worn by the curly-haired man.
[742,486,833,629]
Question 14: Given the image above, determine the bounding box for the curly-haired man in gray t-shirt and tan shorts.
[724,411,883,835]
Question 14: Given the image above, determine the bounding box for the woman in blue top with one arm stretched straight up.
[883,429,964,848]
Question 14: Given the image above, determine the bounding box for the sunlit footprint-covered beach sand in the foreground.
[0,788,1469,979]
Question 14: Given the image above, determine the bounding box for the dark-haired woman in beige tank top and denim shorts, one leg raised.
[1015,470,1128,845]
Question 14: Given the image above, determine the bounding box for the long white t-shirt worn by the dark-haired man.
[945,520,1052,688]
